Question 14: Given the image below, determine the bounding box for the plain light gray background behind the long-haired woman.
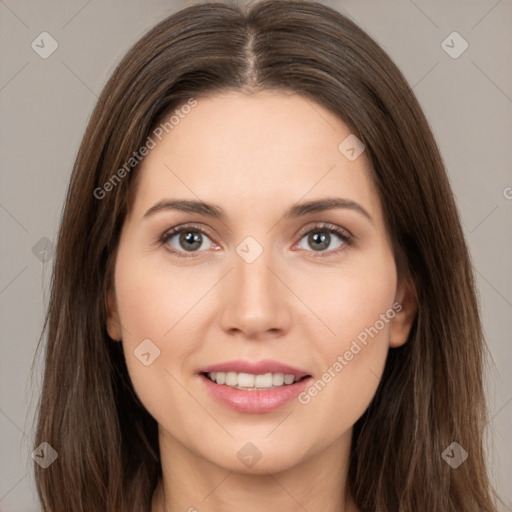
[0,0,512,512]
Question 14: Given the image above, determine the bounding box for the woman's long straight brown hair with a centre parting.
[34,0,496,512]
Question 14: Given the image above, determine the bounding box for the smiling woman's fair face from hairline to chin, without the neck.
[108,91,412,472]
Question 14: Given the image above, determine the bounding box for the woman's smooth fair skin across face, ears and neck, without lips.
[107,91,417,512]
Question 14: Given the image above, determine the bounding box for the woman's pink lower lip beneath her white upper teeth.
[200,375,312,413]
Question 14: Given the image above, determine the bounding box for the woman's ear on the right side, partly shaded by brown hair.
[389,276,418,348]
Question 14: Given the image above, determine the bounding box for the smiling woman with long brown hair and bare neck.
[31,0,496,512]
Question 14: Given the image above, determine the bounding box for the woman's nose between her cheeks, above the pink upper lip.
[221,244,293,340]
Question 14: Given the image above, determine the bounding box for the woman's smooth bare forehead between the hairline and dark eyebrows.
[129,91,375,220]
